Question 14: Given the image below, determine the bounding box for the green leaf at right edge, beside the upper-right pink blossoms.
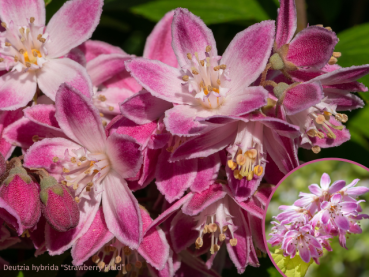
[335,23,369,98]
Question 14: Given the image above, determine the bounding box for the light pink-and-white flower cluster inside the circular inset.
[268,173,369,264]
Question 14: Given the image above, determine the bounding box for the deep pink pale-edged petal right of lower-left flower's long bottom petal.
[138,209,169,270]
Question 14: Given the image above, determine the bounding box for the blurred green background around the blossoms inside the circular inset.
[265,160,369,277]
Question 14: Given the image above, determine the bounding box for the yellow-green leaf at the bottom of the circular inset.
[272,249,313,277]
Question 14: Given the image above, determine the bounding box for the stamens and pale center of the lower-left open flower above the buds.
[53,148,110,198]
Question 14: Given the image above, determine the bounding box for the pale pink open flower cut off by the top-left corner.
[0,0,103,110]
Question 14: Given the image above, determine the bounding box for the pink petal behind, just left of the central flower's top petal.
[143,11,178,67]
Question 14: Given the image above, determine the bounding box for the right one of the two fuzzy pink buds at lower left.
[40,176,79,232]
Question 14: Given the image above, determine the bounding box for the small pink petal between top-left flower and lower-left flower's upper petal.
[23,104,61,132]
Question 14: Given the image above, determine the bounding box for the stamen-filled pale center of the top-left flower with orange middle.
[0,17,48,71]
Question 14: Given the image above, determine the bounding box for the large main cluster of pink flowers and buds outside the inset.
[0,0,369,276]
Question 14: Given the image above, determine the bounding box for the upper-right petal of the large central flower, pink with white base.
[220,20,275,90]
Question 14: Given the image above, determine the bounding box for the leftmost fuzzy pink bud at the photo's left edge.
[0,166,41,229]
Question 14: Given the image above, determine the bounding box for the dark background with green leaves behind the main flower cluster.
[0,0,369,277]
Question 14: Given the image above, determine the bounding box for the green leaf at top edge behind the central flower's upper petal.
[131,0,268,24]
